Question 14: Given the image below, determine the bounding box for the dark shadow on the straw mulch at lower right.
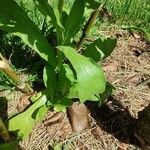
[88,98,150,149]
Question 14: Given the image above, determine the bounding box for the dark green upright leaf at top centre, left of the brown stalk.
[65,0,85,39]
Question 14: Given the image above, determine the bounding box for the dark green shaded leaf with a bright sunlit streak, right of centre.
[83,37,117,62]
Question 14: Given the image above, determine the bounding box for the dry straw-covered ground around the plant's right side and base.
[1,30,150,150]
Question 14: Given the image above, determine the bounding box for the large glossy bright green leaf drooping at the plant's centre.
[57,46,106,102]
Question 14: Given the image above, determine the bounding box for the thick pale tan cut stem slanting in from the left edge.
[0,58,33,95]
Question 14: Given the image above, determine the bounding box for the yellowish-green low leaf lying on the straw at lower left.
[8,95,47,139]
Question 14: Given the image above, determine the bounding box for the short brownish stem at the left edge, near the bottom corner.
[0,117,10,142]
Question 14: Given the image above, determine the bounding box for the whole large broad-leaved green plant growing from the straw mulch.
[0,0,116,148]
